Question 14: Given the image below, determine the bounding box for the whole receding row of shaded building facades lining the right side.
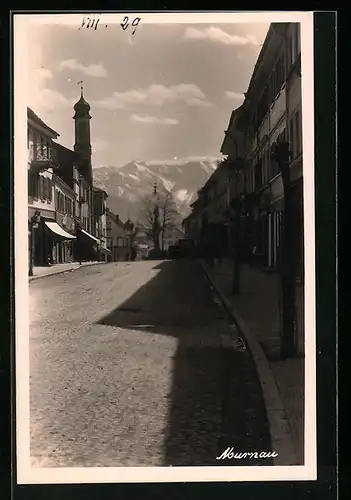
[184,23,303,276]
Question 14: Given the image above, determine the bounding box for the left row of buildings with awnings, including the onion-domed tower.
[27,89,108,275]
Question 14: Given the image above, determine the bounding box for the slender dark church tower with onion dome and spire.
[73,81,93,184]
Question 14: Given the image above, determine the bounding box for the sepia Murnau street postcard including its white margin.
[13,8,317,484]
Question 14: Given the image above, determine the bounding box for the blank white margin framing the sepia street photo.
[13,12,317,484]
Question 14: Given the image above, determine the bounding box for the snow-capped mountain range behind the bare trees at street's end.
[94,157,219,221]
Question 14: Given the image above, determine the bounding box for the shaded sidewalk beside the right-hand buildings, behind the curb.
[202,260,304,464]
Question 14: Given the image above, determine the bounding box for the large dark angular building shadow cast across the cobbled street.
[97,261,271,466]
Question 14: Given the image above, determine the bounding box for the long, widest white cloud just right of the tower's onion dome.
[96,83,210,110]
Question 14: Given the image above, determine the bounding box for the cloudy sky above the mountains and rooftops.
[27,18,269,167]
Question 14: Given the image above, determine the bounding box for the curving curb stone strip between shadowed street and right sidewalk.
[201,264,298,466]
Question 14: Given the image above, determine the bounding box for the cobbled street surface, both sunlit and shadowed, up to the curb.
[30,261,271,467]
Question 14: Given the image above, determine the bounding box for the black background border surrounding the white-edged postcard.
[0,6,338,500]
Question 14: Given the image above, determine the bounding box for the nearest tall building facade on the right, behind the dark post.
[243,23,303,269]
